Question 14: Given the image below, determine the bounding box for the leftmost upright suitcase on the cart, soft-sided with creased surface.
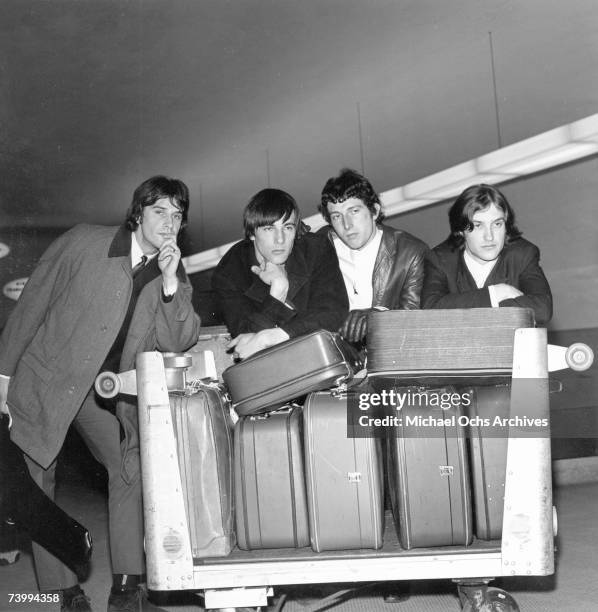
[169,385,235,559]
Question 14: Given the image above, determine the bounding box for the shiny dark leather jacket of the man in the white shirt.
[318,225,428,310]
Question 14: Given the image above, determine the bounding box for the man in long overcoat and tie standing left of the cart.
[0,176,200,612]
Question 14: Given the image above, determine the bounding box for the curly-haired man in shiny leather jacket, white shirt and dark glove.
[319,168,428,342]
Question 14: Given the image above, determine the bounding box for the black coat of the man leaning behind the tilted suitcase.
[212,233,349,338]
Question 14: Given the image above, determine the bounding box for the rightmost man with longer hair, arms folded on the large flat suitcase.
[422,184,552,325]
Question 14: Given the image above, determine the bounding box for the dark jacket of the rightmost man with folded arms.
[422,238,552,325]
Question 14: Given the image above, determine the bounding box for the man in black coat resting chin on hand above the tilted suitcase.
[212,189,347,359]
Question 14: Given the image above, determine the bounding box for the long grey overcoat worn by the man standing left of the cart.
[0,225,199,467]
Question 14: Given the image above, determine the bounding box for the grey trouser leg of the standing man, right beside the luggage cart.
[74,391,145,574]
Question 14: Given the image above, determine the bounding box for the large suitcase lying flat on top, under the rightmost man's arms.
[367,308,534,384]
